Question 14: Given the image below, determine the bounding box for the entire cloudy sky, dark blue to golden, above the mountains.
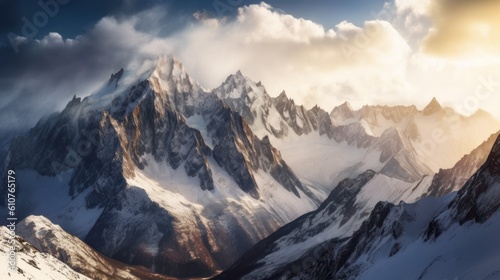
[0,0,500,133]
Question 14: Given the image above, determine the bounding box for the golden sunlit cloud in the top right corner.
[406,0,500,59]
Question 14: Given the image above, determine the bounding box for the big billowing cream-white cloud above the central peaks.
[173,3,410,110]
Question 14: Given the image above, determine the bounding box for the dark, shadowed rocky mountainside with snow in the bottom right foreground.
[217,133,500,279]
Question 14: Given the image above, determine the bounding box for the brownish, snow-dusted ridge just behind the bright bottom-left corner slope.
[16,216,173,280]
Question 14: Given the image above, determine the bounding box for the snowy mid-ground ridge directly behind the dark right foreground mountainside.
[217,170,432,279]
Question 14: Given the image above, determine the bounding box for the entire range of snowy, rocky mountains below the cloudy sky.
[0,56,500,279]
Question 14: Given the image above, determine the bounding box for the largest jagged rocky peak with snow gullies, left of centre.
[1,57,320,277]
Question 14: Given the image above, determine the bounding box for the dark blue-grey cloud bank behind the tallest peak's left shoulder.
[0,9,171,130]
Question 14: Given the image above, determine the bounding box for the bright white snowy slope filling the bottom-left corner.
[0,226,91,280]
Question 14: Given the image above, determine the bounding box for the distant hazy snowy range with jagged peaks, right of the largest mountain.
[213,71,500,197]
